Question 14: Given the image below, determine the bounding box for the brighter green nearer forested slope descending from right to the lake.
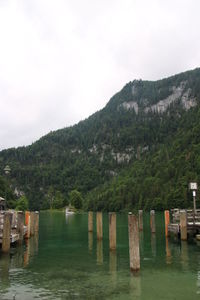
[86,108,200,211]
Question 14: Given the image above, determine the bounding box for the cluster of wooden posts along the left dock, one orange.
[2,211,39,253]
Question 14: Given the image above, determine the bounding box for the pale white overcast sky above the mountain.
[0,0,200,149]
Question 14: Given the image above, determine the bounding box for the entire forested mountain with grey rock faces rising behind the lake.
[0,69,200,210]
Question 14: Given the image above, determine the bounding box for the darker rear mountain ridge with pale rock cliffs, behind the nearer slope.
[0,68,200,209]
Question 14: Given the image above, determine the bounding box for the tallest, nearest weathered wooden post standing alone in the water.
[128,213,140,271]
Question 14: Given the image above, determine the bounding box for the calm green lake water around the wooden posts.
[0,212,200,300]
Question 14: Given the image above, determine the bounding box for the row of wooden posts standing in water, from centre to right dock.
[88,210,178,271]
